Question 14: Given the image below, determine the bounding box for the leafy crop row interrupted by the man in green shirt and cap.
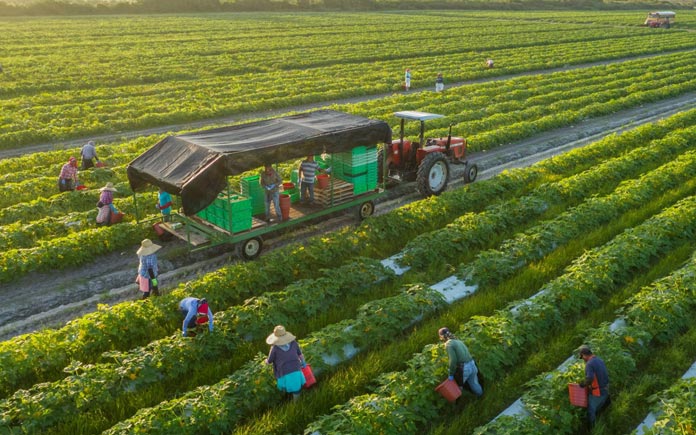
[307,197,696,434]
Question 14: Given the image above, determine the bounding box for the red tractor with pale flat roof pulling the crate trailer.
[380,111,478,196]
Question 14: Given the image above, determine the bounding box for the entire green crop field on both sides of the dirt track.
[0,12,696,435]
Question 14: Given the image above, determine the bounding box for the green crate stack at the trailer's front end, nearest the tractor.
[332,146,378,195]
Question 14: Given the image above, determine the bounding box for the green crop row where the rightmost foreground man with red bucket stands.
[476,250,696,434]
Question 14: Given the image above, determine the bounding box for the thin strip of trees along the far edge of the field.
[0,0,688,17]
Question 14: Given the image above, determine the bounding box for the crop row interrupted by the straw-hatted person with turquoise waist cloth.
[102,135,696,433]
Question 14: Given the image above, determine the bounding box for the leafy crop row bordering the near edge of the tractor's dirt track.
[0,107,696,395]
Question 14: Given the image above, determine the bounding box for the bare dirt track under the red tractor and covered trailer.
[0,89,696,340]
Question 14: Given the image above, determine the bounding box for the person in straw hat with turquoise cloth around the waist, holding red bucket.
[266,325,307,399]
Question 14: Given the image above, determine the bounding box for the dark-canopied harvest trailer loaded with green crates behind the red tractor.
[127,110,391,259]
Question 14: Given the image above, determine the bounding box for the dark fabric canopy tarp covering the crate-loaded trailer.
[127,110,391,215]
